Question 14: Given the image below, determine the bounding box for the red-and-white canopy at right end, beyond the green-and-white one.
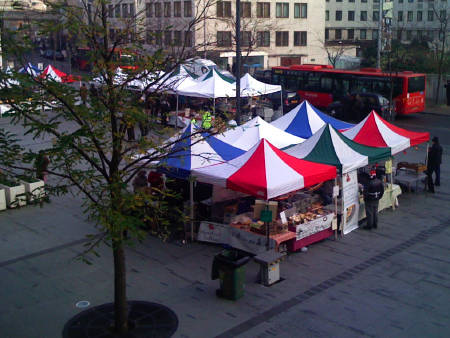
[343,111,430,155]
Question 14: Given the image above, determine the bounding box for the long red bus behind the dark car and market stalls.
[271,64,426,115]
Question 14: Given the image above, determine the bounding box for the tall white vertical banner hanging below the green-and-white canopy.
[341,170,359,235]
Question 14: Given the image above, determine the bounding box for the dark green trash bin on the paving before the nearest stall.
[211,250,250,300]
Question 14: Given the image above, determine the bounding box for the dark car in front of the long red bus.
[326,93,396,122]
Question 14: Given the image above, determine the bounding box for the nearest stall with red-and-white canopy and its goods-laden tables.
[193,139,336,254]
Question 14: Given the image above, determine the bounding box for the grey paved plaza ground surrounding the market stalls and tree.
[0,114,450,338]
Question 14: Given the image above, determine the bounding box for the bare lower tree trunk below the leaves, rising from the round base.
[113,240,128,334]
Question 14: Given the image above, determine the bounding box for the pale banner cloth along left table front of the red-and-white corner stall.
[197,222,276,254]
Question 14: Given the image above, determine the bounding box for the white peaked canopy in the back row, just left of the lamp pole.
[177,69,236,99]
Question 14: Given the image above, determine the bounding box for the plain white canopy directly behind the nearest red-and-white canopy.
[217,116,304,150]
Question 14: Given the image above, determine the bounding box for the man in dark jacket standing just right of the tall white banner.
[363,170,384,229]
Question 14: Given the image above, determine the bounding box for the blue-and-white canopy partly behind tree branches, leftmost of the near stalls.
[158,123,244,178]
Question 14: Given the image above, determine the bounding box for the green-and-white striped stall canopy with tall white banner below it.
[285,124,396,234]
